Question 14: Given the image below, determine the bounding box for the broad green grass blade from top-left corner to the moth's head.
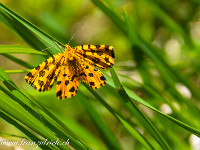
[0,3,62,55]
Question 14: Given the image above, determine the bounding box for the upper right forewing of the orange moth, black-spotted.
[75,45,115,69]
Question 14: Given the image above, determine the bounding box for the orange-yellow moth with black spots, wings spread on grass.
[25,44,115,99]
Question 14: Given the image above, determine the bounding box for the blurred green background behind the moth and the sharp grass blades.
[0,0,200,150]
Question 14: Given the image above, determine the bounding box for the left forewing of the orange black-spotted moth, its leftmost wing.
[25,53,63,92]
